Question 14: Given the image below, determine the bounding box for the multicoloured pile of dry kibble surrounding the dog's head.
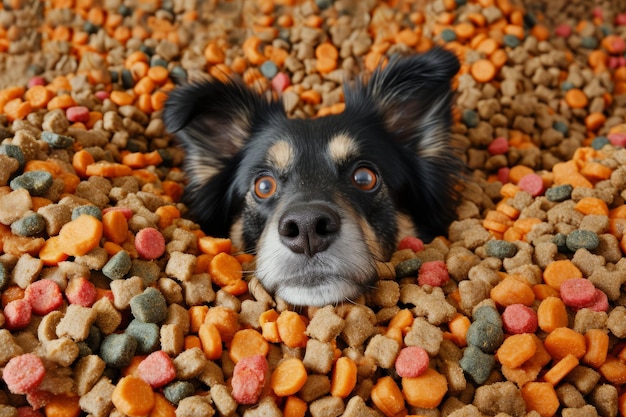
[0,0,626,417]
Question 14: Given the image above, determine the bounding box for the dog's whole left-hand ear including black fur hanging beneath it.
[163,80,282,236]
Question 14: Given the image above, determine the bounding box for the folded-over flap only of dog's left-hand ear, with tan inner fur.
[163,80,276,191]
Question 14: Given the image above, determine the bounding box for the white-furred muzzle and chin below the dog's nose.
[256,219,378,306]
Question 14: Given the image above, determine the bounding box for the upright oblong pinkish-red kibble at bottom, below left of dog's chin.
[231,355,269,404]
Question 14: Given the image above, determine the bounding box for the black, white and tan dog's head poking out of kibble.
[163,48,465,306]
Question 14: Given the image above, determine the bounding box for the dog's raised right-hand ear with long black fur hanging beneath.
[345,48,464,237]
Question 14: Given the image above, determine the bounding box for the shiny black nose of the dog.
[278,203,341,256]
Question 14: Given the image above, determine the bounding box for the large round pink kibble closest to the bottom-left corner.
[2,353,46,394]
